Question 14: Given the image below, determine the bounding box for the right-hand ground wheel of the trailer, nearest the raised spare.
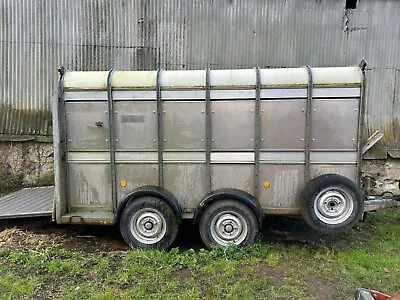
[199,200,259,248]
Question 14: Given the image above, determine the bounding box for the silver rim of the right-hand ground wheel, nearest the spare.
[210,211,248,246]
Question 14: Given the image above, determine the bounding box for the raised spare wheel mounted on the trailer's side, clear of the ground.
[301,174,364,234]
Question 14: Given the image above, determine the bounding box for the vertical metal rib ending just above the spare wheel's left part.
[304,66,313,182]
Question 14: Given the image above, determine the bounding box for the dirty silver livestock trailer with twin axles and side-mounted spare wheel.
[49,66,396,249]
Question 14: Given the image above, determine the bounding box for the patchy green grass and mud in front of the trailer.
[0,209,400,300]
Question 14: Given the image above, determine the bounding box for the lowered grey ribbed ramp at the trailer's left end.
[0,186,54,219]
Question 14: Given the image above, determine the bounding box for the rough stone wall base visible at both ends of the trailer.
[0,142,400,195]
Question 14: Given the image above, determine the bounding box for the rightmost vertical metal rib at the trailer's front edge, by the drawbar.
[356,61,366,186]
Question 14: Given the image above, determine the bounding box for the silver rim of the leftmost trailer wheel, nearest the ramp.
[131,208,167,245]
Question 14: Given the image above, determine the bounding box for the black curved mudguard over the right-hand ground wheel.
[193,189,264,227]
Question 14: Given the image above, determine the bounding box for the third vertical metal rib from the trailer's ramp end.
[156,69,164,187]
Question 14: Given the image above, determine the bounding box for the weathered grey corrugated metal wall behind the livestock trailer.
[0,0,400,148]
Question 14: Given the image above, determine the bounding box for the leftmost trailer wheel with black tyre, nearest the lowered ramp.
[119,197,178,249]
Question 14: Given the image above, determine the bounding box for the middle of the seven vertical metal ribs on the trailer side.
[206,68,212,193]
